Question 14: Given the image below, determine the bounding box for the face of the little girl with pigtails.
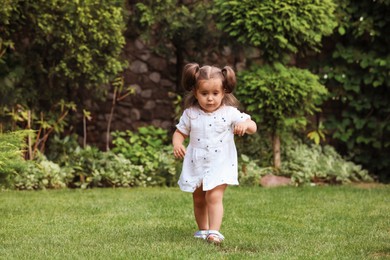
[194,79,225,113]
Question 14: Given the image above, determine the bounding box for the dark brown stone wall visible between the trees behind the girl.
[81,39,254,149]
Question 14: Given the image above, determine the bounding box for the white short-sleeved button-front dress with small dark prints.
[176,106,250,192]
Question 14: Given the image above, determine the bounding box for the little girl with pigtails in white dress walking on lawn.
[172,63,257,244]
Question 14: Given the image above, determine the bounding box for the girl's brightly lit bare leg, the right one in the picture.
[206,184,227,231]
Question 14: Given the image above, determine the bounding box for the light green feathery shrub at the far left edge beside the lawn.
[0,130,32,187]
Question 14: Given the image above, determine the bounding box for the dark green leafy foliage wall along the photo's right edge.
[313,0,390,180]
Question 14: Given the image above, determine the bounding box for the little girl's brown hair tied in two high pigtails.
[181,63,239,108]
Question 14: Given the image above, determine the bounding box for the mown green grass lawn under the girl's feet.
[0,186,390,259]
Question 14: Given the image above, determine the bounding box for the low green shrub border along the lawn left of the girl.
[0,127,178,190]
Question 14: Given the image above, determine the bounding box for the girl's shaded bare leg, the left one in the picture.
[192,186,209,230]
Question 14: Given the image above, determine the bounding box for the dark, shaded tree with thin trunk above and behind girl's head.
[130,0,220,91]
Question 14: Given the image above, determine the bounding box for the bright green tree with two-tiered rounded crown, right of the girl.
[214,0,336,168]
